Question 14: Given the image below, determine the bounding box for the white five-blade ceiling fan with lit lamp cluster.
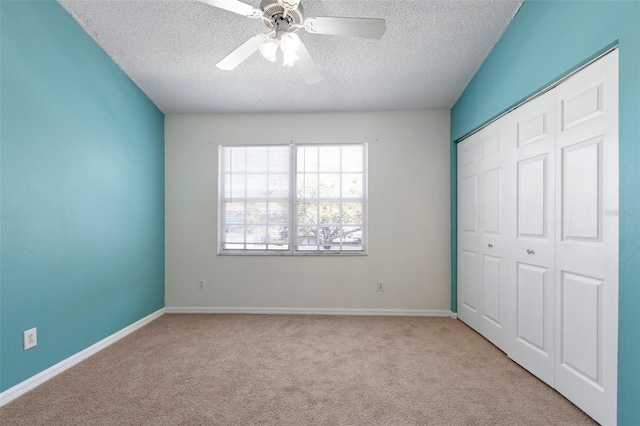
[197,0,387,84]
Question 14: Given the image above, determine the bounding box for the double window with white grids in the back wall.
[219,144,367,254]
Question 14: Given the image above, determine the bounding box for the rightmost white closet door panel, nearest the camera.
[555,50,618,424]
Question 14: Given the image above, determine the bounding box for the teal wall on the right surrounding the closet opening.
[451,0,640,425]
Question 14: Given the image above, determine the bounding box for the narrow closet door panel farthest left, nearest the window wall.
[457,135,480,331]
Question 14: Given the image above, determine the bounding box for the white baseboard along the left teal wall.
[0,308,165,407]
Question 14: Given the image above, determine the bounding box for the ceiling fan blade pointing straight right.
[304,17,387,38]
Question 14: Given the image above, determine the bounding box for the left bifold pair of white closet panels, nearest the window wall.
[458,123,514,351]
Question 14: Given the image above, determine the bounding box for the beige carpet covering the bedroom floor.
[0,315,594,425]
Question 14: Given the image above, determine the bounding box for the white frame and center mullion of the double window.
[217,143,369,256]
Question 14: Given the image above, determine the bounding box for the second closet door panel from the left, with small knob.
[479,117,515,352]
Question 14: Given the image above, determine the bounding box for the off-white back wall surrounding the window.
[165,111,451,311]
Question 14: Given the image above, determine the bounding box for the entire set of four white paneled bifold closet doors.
[458,50,618,424]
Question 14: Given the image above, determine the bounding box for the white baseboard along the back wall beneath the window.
[165,306,455,317]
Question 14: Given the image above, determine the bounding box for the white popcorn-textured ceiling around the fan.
[59,0,522,114]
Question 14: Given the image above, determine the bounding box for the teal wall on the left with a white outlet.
[0,1,164,391]
